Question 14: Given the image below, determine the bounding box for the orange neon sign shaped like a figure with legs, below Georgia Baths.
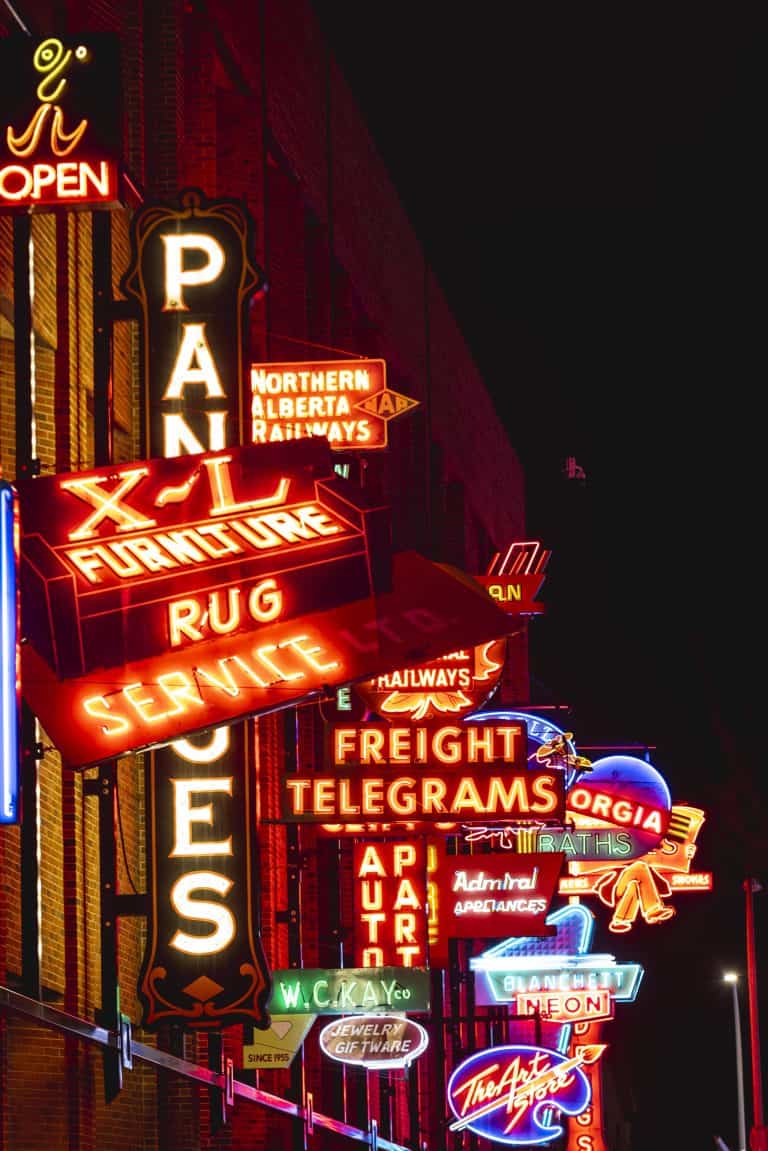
[558,803,712,935]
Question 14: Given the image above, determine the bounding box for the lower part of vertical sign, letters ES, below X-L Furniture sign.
[138,725,269,1029]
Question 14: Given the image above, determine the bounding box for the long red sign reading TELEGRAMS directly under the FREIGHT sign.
[282,765,564,823]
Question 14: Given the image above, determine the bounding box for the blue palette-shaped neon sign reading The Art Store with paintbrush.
[448,1044,602,1145]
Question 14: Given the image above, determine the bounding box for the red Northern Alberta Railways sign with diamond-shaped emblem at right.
[251,359,418,451]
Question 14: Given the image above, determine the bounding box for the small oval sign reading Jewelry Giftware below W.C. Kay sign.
[318,1014,429,1072]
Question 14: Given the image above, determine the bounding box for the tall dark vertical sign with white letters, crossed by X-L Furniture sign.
[123,189,271,1029]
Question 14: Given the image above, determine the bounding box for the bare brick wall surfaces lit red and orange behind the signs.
[0,0,526,1151]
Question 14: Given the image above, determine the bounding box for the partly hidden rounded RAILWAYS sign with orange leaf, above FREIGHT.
[357,639,507,723]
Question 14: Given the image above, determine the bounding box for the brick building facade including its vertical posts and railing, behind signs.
[0,0,527,1151]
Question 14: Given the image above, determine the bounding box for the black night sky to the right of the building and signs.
[314,0,768,1151]
